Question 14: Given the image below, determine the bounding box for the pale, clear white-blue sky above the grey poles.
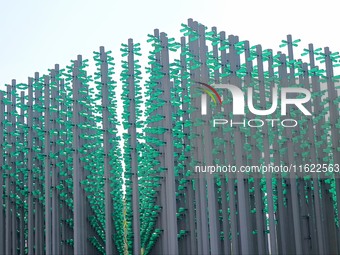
[0,0,340,88]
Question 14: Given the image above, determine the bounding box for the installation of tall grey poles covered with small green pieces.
[0,19,340,255]
